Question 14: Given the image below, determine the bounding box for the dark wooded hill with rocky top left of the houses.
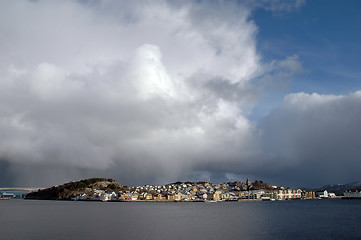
[26,178,126,200]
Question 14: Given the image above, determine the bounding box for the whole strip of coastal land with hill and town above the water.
[0,178,361,202]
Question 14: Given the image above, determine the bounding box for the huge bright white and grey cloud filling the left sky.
[0,1,260,185]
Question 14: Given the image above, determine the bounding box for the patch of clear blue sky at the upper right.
[250,0,361,120]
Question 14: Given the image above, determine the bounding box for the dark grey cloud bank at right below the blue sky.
[260,92,361,188]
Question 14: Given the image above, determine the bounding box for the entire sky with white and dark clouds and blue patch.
[0,0,361,187]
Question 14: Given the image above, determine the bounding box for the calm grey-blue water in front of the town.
[0,199,361,240]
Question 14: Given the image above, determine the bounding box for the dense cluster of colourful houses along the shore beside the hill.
[73,179,330,202]
